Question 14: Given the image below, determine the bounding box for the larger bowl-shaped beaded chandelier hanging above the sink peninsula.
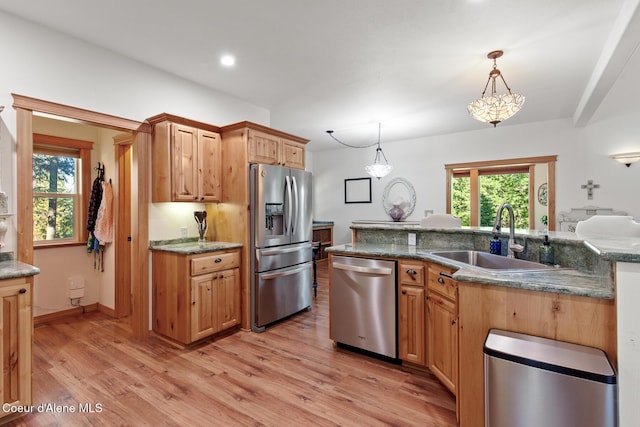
[467,50,524,127]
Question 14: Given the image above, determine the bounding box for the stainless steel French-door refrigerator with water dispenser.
[249,164,312,332]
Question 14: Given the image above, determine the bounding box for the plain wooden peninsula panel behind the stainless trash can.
[457,282,617,427]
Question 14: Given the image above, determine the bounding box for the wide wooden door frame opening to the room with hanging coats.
[11,93,151,338]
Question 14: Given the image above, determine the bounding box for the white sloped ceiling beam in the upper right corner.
[573,0,640,127]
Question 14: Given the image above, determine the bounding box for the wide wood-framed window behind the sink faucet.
[445,156,556,230]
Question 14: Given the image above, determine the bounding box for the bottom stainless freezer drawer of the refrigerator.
[255,262,312,327]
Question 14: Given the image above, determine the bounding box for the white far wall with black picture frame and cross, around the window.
[313,115,640,244]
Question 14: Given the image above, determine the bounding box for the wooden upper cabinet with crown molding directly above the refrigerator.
[222,122,309,169]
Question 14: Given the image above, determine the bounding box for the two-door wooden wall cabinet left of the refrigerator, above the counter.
[148,114,222,202]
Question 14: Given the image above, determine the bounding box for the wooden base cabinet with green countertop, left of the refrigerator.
[153,249,241,345]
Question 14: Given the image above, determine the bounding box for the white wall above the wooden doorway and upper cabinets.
[0,12,270,258]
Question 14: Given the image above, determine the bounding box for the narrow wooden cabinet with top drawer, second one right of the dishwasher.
[427,264,458,395]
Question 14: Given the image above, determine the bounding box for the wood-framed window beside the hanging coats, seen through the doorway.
[33,134,93,246]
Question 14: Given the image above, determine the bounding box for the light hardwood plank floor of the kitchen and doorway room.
[9,264,456,426]
